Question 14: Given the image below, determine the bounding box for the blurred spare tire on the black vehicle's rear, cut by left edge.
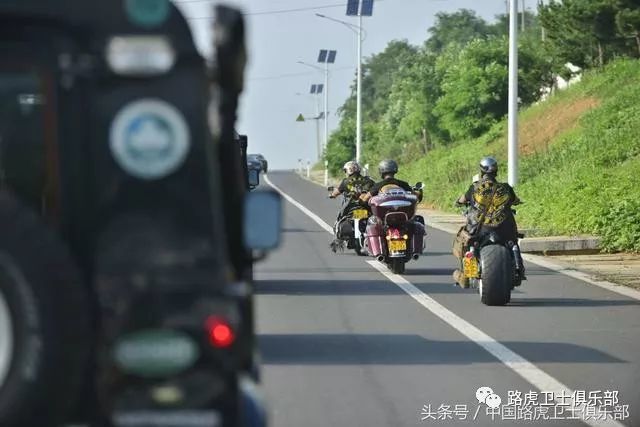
[0,191,91,427]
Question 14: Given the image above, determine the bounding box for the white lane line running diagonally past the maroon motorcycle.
[264,176,625,427]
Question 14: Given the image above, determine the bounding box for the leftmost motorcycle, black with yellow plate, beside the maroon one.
[327,187,371,256]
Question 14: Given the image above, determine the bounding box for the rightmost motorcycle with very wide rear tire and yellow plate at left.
[454,203,524,305]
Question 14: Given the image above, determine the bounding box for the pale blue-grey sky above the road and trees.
[173,0,516,169]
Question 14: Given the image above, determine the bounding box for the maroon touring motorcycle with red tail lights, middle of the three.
[366,182,426,274]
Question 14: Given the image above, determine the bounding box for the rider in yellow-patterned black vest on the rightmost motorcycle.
[454,157,526,284]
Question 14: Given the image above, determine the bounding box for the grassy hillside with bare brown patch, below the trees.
[400,60,640,252]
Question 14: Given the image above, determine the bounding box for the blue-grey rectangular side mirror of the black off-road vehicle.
[243,190,282,251]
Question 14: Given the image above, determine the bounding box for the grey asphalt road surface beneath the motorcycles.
[256,172,640,427]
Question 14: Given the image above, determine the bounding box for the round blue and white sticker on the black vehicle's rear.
[109,98,191,180]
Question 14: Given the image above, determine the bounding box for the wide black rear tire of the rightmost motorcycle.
[480,245,513,306]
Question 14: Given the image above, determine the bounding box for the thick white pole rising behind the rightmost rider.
[508,0,518,187]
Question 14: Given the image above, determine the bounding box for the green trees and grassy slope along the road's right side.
[325,0,640,251]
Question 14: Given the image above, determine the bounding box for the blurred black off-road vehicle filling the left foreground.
[0,0,272,427]
